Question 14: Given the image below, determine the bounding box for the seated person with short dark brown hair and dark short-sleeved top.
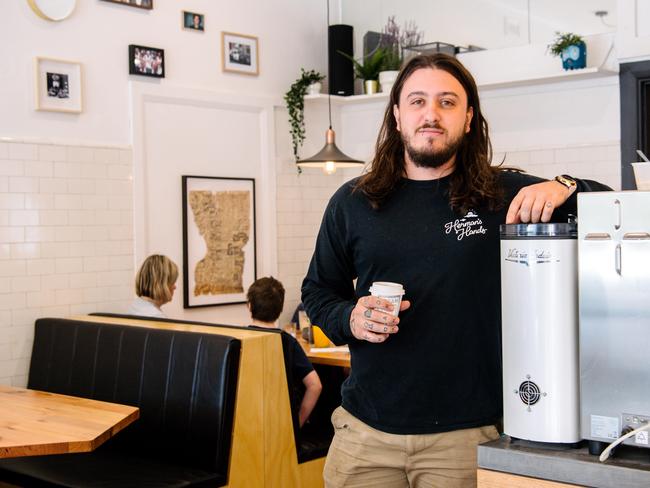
[246,276,323,427]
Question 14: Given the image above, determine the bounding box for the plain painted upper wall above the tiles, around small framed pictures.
[0,0,326,144]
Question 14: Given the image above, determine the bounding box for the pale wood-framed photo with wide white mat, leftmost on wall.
[35,57,82,113]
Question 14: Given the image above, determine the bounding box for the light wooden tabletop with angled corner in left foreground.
[0,385,140,458]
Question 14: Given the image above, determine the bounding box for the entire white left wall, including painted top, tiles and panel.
[0,0,326,385]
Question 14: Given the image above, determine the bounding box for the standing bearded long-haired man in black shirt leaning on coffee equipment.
[302,54,607,488]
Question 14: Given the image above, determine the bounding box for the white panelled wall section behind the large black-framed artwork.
[132,86,277,325]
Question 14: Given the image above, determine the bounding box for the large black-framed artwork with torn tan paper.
[182,176,257,308]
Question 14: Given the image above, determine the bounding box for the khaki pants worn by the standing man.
[323,407,499,488]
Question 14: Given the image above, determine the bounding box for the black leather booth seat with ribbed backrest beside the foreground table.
[0,319,241,488]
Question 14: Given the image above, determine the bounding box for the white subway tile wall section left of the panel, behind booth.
[0,142,134,386]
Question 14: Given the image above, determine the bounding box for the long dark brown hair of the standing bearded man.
[355,54,502,213]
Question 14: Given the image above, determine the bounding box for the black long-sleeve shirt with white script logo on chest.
[302,171,607,434]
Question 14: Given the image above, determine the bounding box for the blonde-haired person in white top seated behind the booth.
[129,254,178,318]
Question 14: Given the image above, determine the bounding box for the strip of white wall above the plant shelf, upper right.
[342,0,617,56]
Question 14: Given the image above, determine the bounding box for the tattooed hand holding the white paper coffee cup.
[350,295,411,342]
